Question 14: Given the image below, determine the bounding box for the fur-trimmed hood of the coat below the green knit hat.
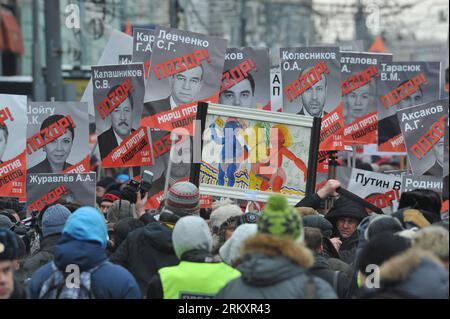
[238,234,314,286]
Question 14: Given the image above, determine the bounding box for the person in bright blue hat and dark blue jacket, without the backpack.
[29,207,141,299]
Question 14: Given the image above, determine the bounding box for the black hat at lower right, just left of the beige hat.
[359,232,411,274]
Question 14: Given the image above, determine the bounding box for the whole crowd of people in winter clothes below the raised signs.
[0,176,449,299]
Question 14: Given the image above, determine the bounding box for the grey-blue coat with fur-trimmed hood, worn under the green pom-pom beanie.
[216,234,336,299]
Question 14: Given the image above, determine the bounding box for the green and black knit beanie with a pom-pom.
[258,195,303,240]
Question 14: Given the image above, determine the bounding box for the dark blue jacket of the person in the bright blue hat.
[28,236,141,299]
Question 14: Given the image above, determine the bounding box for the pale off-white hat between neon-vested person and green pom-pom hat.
[219,224,258,267]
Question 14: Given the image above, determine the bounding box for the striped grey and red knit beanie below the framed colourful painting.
[165,182,200,217]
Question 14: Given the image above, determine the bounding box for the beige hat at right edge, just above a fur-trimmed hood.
[413,226,449,270]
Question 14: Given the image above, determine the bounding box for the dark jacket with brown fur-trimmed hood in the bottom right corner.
[358,248,449,299]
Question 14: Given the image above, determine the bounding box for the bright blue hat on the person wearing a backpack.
[63,207,108,248]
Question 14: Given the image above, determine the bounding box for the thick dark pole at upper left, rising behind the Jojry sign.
[44,0,63,101]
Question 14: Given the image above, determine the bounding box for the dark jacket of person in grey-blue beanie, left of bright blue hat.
[22,234,61,278]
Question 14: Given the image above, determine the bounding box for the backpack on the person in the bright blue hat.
[39,261,108,299]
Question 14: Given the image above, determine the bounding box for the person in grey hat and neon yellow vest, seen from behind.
[147,216,240,299]
